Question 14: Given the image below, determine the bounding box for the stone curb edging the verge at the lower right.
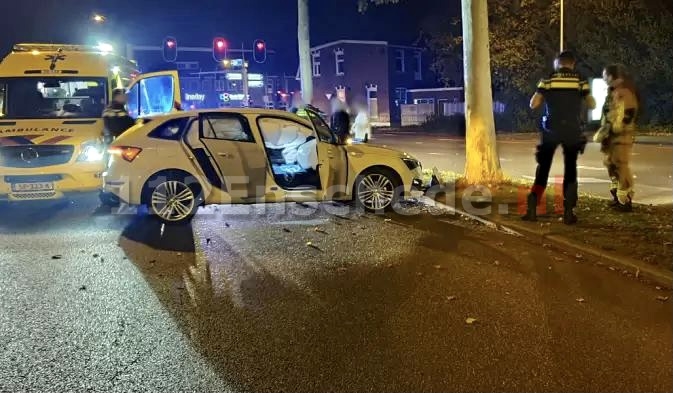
[494,219,673,288]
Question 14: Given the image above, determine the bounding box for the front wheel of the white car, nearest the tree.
[353,168,403,213]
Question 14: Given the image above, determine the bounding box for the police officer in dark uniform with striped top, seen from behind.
[522,51,596,225]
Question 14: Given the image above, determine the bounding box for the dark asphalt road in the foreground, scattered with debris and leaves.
[0,199,673,392]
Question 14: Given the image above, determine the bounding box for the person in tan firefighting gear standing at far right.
[594,64,639,211]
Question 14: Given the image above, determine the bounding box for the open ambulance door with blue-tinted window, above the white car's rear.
[127,71,181,119]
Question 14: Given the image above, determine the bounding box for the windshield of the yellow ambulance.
[0,76,107,119]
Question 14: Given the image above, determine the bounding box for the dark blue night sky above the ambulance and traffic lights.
[0,0,460,71]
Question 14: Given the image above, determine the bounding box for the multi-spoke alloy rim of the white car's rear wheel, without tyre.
[150,180,196,222]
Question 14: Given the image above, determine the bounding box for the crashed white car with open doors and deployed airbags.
[103,108,422,223]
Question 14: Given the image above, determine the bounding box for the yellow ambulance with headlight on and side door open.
[0,44,180,202]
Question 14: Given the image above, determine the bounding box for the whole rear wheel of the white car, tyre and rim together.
[142,172,203,224]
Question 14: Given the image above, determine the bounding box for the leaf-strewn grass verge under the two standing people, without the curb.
[426,171,673,270]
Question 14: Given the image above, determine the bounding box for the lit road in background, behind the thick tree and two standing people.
[372,132,673,204]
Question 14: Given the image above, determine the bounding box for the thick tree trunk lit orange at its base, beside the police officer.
[462,0,502,185]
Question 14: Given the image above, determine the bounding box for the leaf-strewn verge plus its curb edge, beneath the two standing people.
[436,179,673,288]
